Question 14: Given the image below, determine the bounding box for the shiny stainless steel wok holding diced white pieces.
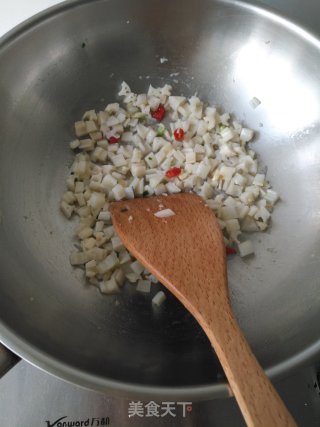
[0,0,320,399]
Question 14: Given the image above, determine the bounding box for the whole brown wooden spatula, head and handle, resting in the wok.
[111,193,296,427]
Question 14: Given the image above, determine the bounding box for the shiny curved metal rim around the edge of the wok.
[0,0,320,401]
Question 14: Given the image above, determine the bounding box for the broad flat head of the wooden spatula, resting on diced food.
[110,193,228,317]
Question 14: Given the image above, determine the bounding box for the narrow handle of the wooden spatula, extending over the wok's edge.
[206,309,297,427]
